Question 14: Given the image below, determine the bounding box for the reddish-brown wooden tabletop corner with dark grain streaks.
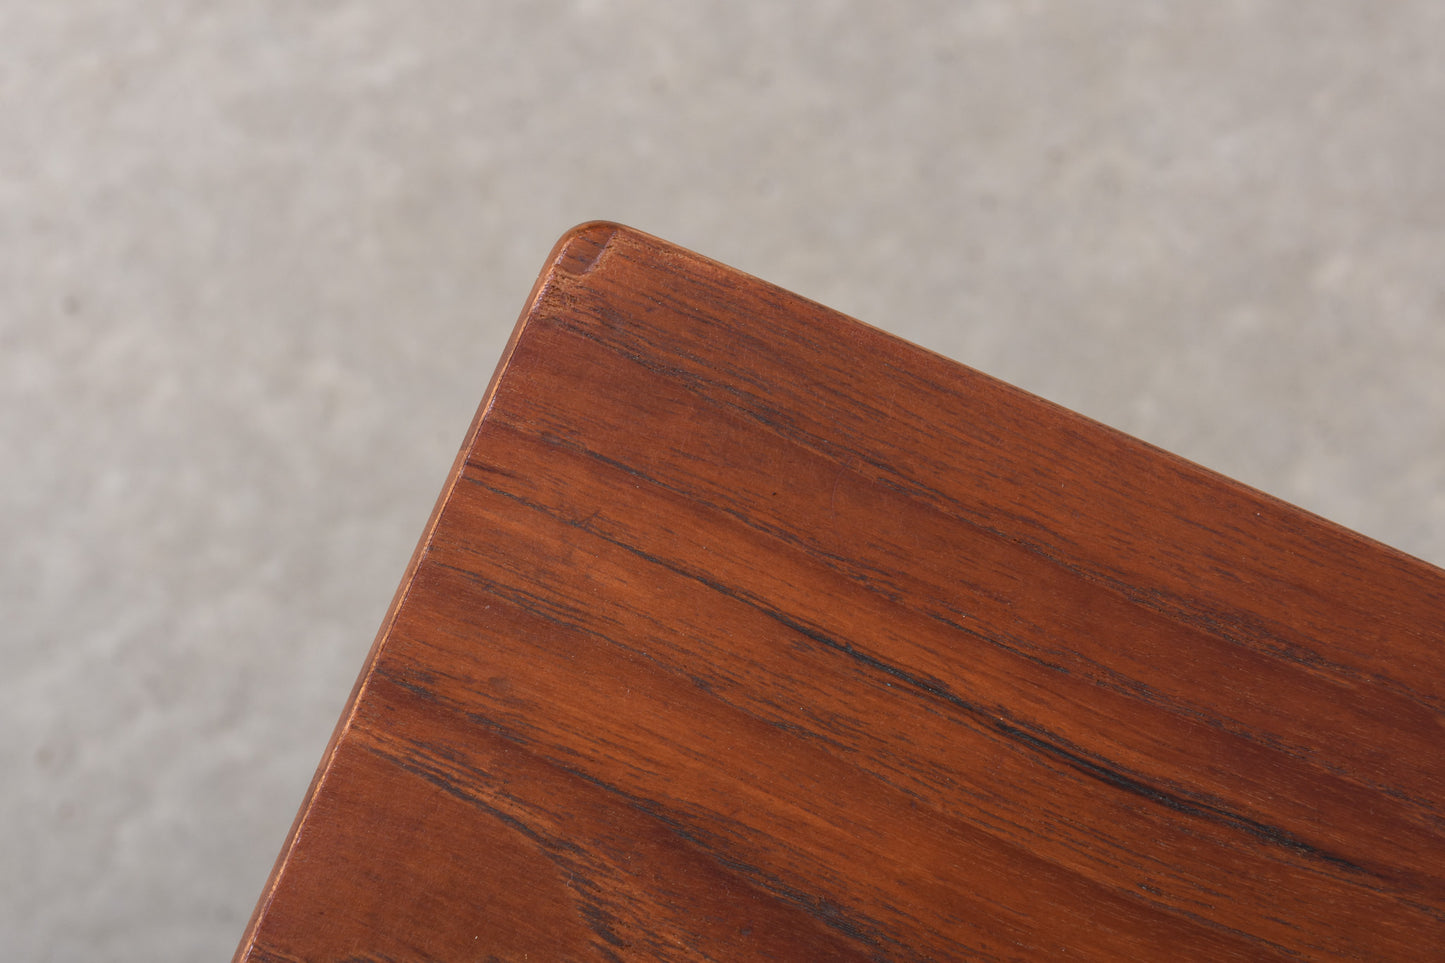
[237,224,1445,963]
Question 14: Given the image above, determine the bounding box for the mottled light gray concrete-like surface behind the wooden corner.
[0,0,1445,960]
